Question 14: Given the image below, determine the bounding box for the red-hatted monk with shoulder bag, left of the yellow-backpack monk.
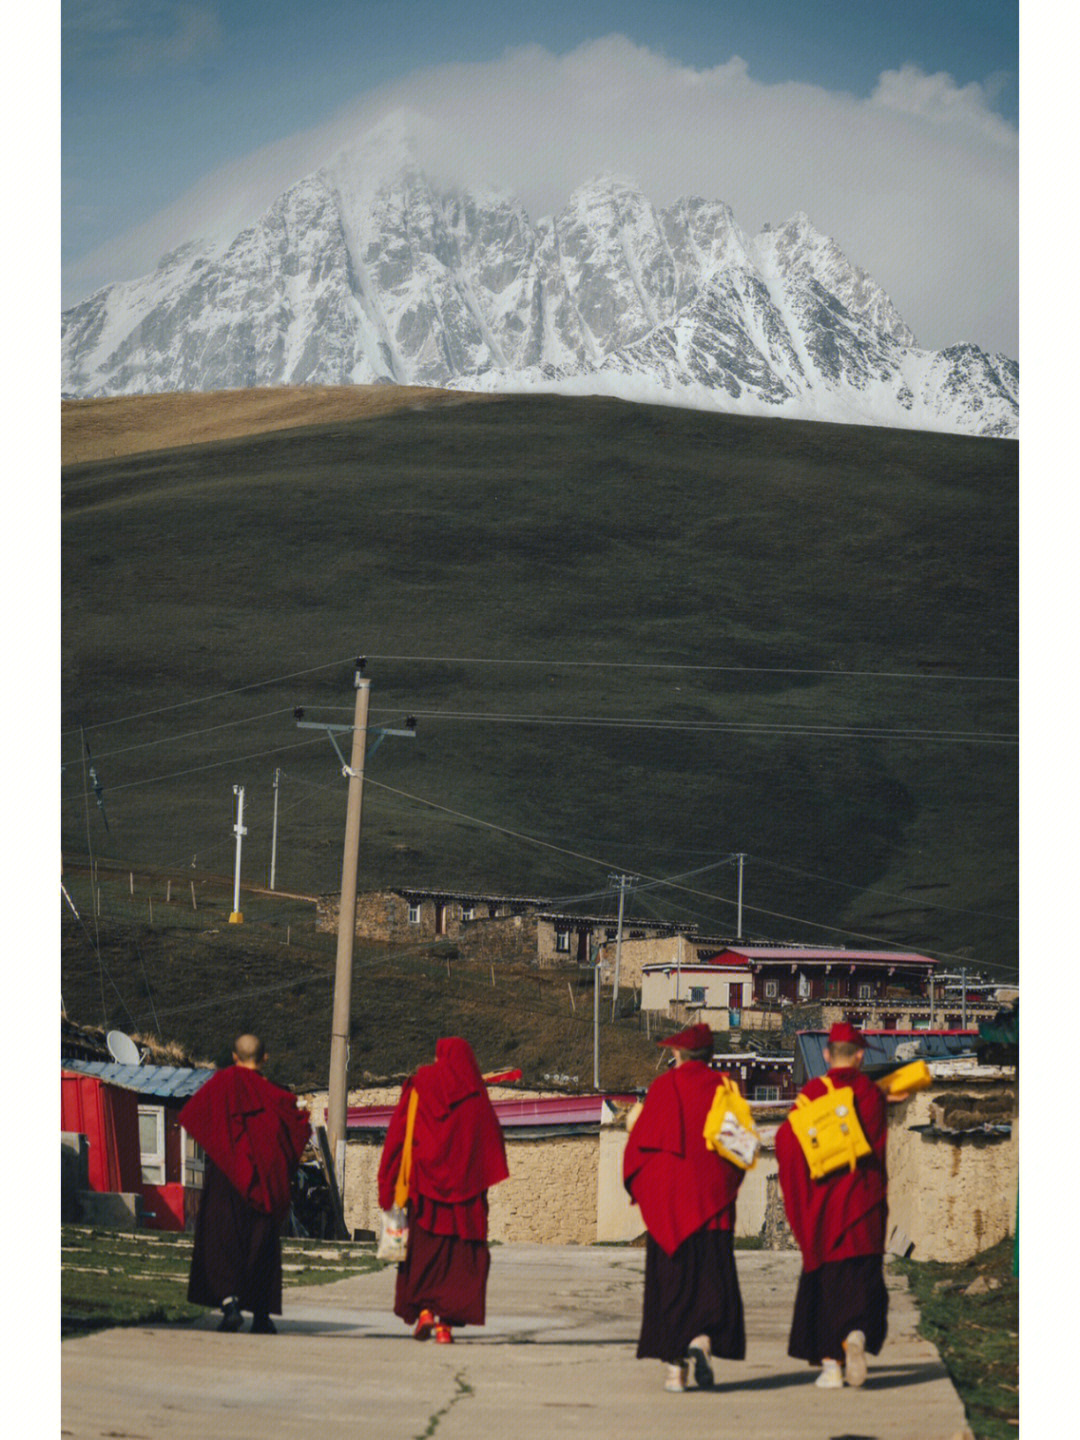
[622,1025,746,1391]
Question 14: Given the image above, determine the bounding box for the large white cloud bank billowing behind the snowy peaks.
[69,36,1018,356]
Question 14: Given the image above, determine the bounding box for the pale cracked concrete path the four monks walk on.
[62,1246,966,1440]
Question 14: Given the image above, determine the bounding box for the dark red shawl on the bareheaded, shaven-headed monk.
[179,1066,311,1220]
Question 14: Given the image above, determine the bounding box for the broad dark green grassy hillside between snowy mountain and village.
[62,396,1017,1048]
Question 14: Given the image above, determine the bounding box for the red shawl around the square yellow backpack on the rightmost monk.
[776,1066,887,1272]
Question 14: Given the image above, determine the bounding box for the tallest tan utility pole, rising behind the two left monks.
[327,670,372,1187]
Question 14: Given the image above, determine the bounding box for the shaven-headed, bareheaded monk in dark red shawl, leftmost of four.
[180,1035,311,1335]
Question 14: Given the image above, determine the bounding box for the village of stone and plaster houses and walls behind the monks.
[62,852,1018,1260]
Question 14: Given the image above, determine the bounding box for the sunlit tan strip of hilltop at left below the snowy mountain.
[60,384,492,465]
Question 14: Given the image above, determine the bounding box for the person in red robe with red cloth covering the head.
[379,1037,510,1345]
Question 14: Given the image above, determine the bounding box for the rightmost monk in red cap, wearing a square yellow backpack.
[776,1021,888,1390]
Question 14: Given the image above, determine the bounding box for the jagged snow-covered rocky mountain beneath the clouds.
[62,131,1018,436]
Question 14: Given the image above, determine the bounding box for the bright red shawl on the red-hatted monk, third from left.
[622,1060,744,1256]
